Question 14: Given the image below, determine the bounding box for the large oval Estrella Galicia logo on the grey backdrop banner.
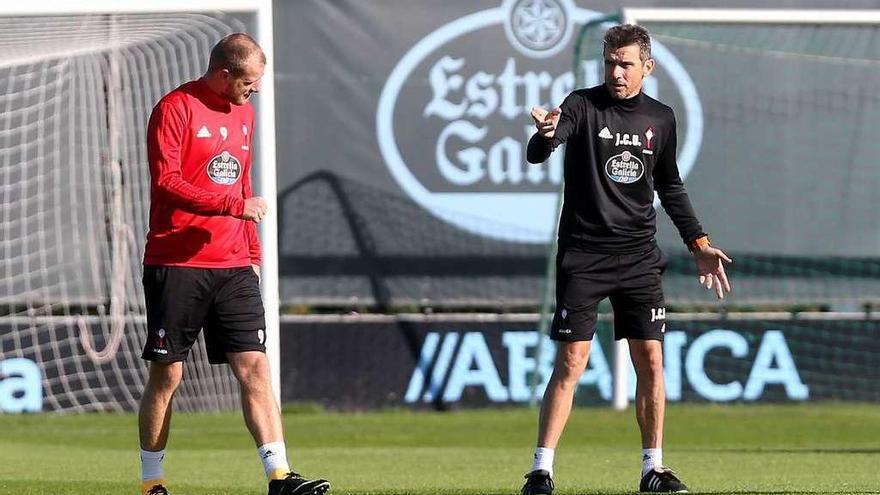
[376,0,703,243]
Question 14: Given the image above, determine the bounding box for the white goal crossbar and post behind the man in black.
[612,8,880,410]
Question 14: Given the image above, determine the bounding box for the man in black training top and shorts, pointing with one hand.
[522,25,731,495]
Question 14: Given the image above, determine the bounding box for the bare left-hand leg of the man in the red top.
[138,362,183,452]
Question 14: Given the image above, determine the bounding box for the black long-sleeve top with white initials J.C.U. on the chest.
[527,85,704,253]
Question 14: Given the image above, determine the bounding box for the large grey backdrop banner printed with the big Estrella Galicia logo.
[275,0,880,308]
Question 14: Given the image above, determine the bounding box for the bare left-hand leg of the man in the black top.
[538,341,591,449]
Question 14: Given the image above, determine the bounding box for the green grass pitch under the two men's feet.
[0,404,880,495]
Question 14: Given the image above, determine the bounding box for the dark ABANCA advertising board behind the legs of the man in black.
[281,316,880,409]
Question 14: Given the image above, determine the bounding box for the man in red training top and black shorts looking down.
[138,33,330,495]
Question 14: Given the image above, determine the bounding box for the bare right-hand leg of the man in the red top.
[227,351,284,446]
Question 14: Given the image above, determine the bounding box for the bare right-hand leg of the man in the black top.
[629,339,666,449]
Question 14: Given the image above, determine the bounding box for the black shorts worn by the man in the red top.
[141,266,266,364]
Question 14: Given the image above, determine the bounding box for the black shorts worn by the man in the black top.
[550,246,667,342]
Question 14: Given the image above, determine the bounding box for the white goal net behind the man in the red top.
[0,8,262,411]
